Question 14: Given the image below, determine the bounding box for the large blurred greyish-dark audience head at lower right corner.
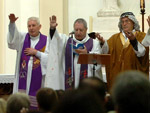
[111,71,150,113]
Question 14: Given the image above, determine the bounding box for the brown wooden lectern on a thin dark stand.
[78,54,110,76]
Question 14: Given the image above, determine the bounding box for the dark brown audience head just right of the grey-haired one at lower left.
[36,87,58,112]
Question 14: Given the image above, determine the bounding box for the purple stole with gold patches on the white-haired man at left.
[18,33,47,107]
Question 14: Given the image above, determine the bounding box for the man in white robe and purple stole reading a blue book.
[45,16,107,90]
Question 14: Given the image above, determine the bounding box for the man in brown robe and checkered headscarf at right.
[97,12,149,89]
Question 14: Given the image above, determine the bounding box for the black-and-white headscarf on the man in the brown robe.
[118,14,140,32]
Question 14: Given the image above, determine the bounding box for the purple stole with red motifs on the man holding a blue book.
[65,38,93,89]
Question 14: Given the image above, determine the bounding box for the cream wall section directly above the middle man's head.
[68,0,103,32]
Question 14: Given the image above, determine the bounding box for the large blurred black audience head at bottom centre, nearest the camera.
[53,90,105,113]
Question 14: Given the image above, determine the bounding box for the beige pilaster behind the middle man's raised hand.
[40,0,67,35]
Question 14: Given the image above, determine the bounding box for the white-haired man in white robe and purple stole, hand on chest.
[8,14,49,108]
